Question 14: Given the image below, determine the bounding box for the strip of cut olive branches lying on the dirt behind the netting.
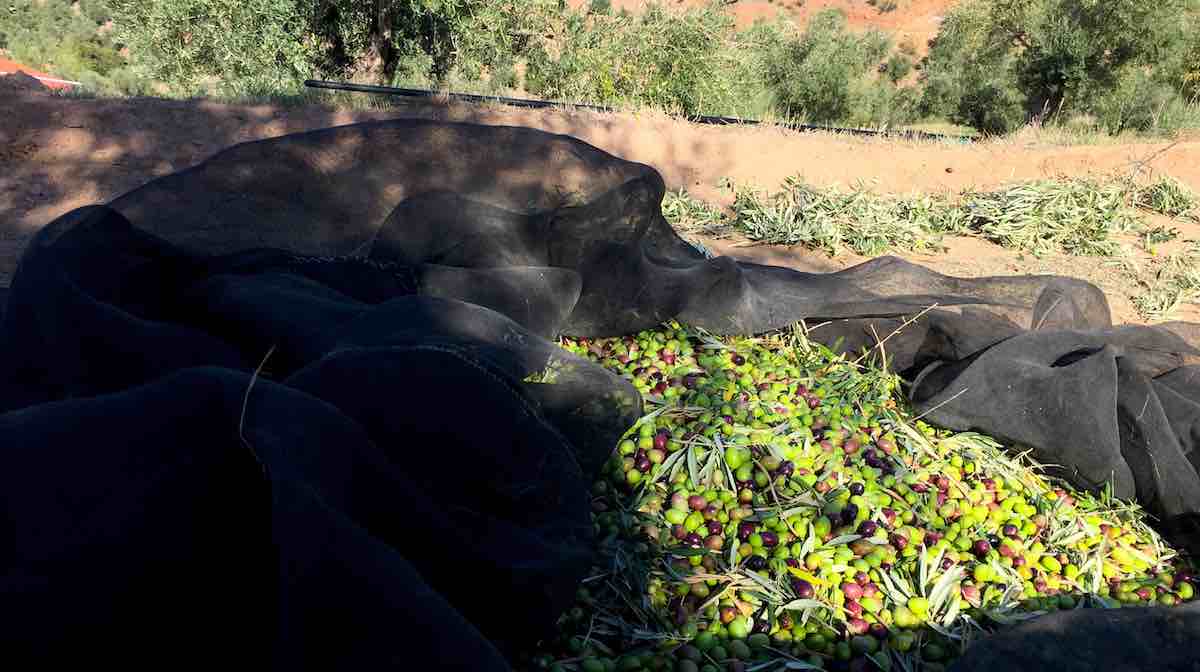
[662,178,1198,256]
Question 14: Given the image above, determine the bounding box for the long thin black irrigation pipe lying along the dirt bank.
[304,79,976,144]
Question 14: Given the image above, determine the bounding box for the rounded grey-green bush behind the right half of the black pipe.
[767,10,890,124]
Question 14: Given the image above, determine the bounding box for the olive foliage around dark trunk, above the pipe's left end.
[112,0,557,95]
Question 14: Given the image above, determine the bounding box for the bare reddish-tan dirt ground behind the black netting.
[7,80,1200,322]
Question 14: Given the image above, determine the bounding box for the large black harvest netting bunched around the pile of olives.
[7,121,1200,670]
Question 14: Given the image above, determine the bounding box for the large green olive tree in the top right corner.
[924,0,1194,133]
